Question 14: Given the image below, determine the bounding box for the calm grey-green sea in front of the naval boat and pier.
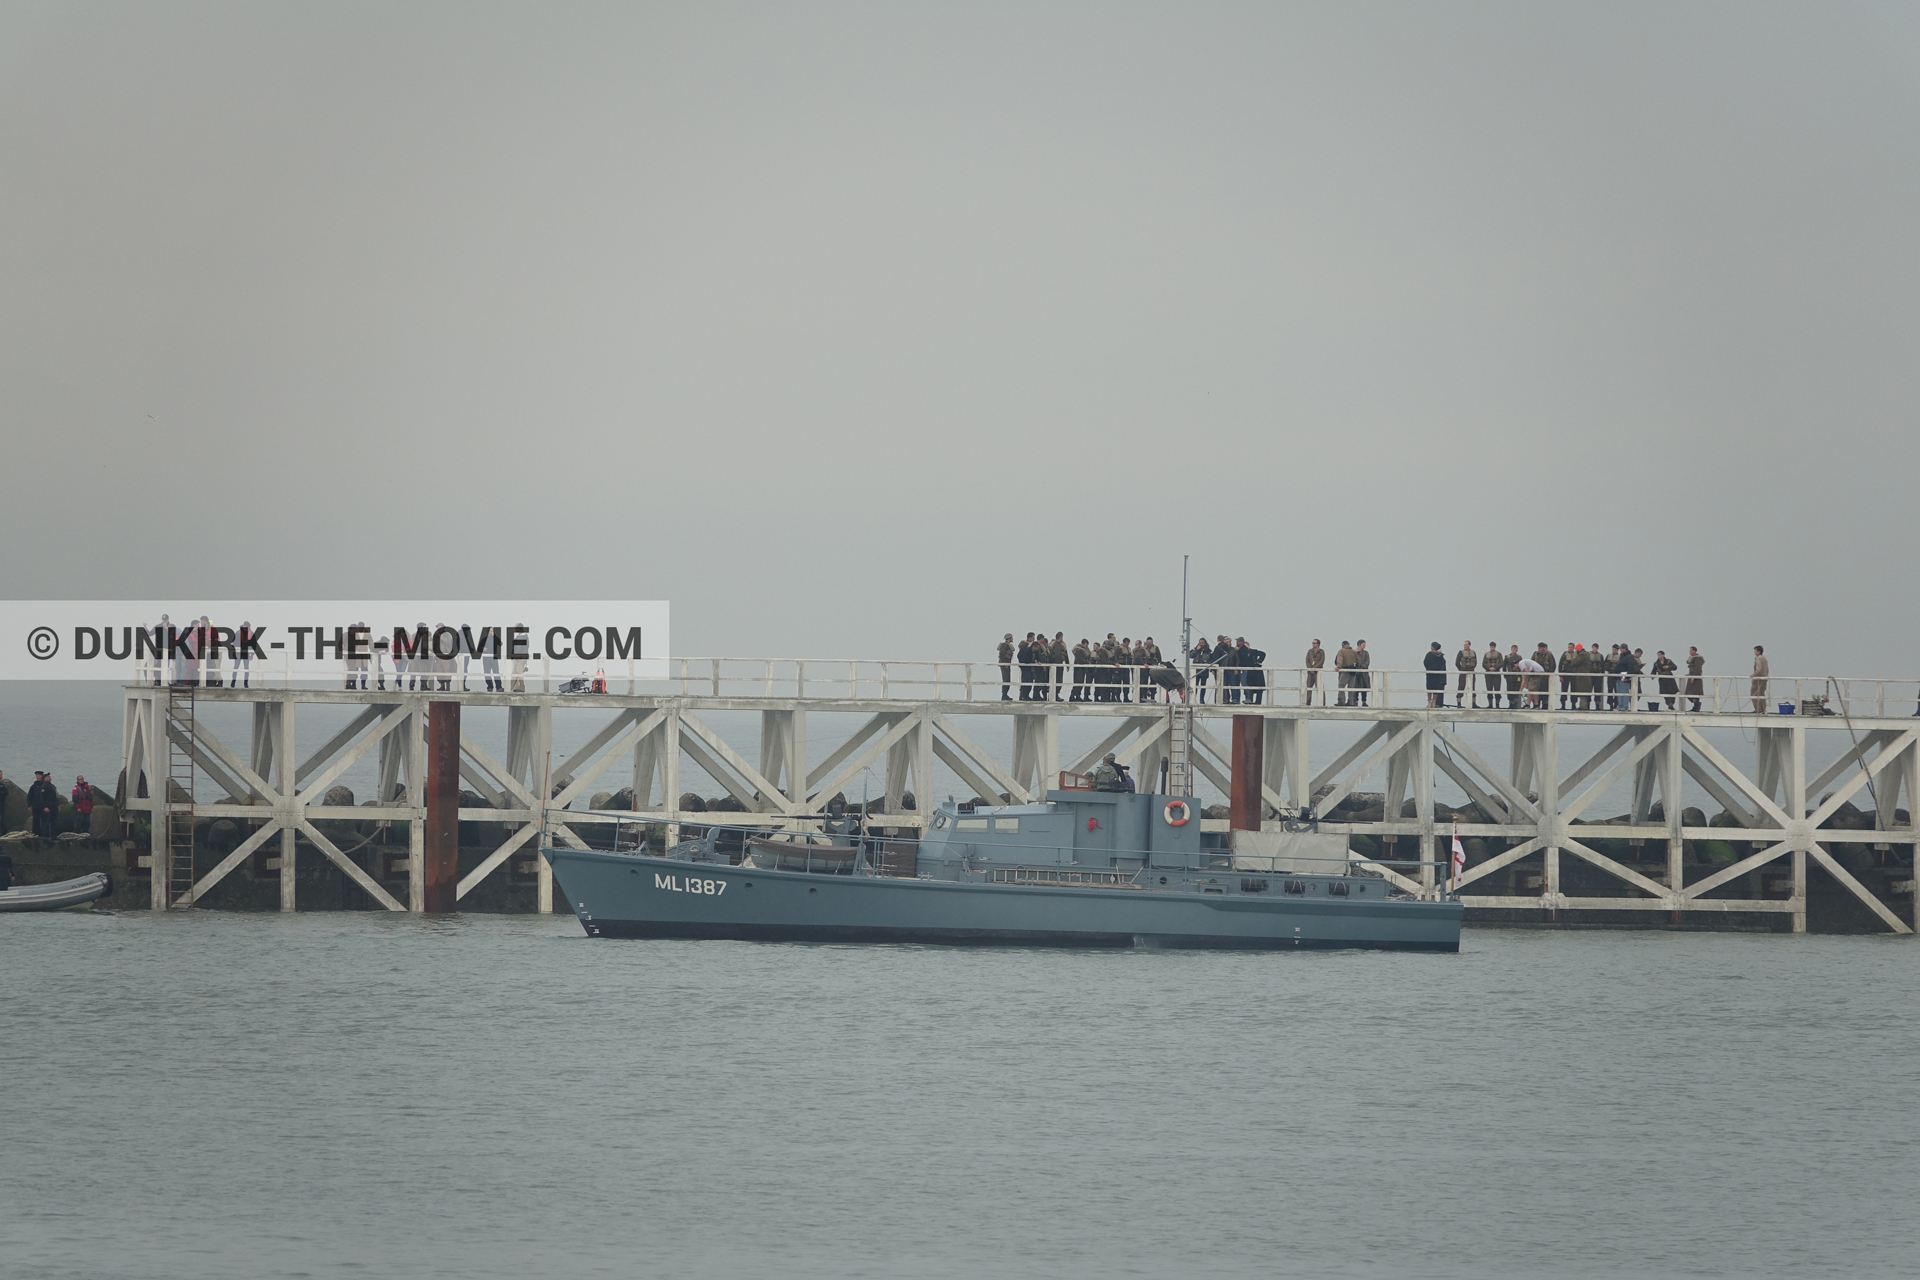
[0,912,1920,1280]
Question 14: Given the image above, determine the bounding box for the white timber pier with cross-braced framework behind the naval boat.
[123,658,1920,933]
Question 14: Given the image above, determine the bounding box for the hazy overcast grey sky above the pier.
[0,4,1920,676]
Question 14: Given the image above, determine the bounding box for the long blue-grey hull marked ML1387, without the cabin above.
[543,848,1461,952]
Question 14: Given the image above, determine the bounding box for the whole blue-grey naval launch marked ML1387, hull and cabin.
[541,791,1461,952]
